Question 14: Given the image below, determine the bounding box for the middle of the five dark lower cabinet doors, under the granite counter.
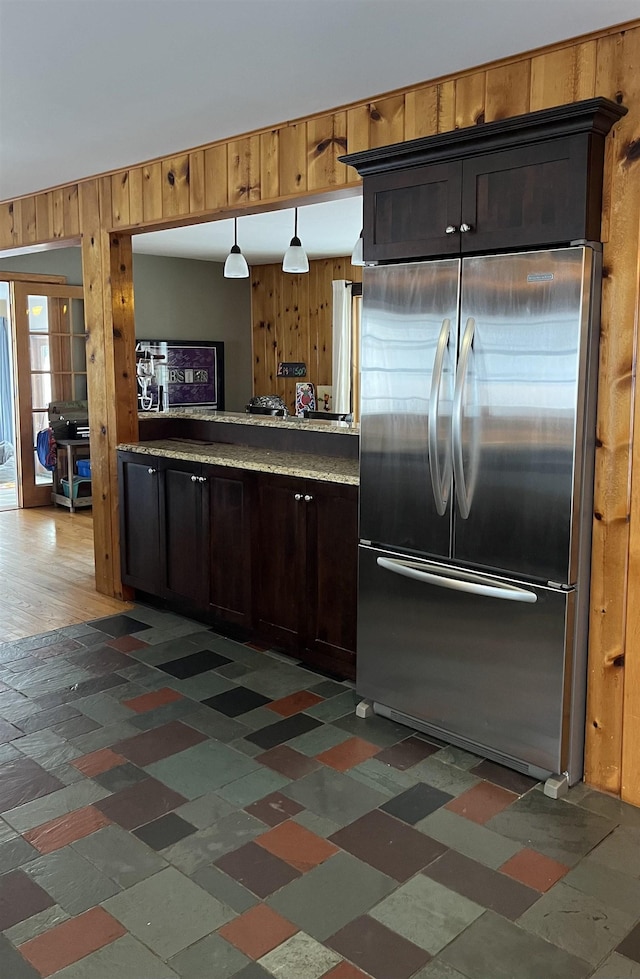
[202,466,254,628]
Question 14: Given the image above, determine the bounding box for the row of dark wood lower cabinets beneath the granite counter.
[118,452,358,677]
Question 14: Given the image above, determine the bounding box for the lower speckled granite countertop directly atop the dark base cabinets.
[118,440,359,486]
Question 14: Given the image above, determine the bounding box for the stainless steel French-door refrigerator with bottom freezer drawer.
[356,246,601,792]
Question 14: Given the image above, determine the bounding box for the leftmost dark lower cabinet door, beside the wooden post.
[118,452,161,595]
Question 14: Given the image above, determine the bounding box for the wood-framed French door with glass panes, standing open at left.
[12,282,87,507]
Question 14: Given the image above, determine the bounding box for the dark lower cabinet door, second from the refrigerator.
[253,476,306,650]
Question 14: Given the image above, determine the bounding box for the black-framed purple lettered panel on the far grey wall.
[136,340,224,411]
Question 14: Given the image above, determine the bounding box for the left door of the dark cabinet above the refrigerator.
[363,160,462,262]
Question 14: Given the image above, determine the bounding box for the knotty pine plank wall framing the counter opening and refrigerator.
[0,20,640,805]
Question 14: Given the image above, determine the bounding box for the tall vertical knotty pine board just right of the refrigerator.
[585,30,640,794]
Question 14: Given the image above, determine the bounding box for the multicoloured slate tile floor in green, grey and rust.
[0,606,640,979]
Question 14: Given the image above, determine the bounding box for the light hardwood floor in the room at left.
[0,507,132,642]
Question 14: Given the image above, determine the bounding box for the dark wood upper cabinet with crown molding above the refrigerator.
[340,98,627,262]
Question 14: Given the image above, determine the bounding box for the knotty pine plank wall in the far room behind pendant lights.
[251,258,362,413]
